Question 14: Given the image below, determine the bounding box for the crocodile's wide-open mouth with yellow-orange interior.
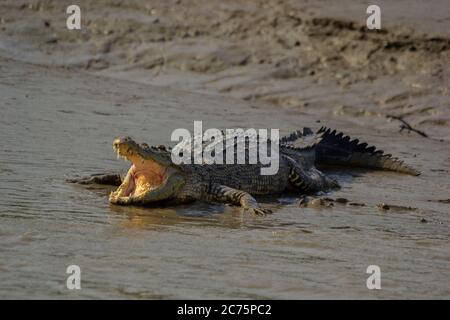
[113,138,167,197]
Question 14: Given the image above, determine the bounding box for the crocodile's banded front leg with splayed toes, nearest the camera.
[206,184,272,215]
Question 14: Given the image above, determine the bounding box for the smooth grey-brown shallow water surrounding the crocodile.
[0,59,450,299]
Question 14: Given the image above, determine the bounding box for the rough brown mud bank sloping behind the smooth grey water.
[0,0,450,140]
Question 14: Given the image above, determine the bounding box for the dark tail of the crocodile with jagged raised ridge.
[316,127,420,176]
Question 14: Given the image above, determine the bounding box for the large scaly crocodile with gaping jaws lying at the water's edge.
[70,127,420,215]
